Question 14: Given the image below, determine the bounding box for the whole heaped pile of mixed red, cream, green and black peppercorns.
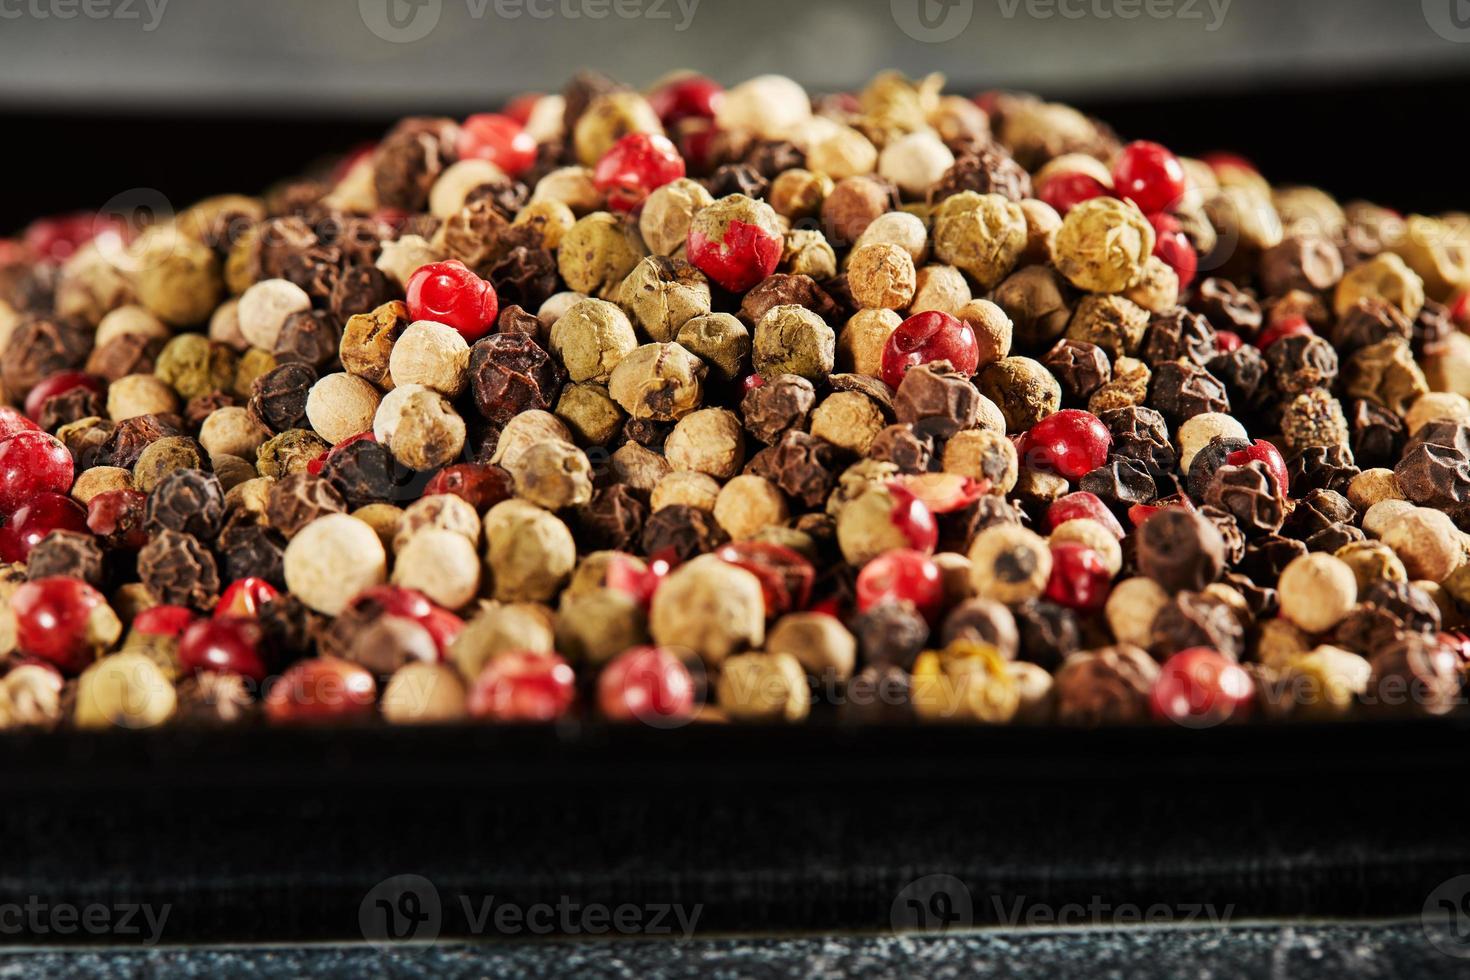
[0,73,1470,727]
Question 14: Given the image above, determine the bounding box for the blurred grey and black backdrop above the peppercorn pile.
[0,0,1470,227]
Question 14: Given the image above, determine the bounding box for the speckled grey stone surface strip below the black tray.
[0,920,1470,980]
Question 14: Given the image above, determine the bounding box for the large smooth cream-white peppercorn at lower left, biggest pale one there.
[284,514,388,616]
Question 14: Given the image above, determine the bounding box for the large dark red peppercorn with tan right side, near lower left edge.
[10,576,122,674]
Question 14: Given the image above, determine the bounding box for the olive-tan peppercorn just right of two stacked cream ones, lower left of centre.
[485,500,576,602]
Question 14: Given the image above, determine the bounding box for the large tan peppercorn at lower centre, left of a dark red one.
[648,555,770,667]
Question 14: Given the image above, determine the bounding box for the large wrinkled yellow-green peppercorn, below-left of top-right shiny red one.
[1054,197,1154,292]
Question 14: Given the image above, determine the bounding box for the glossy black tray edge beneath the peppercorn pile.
[0,718,1470,943]
